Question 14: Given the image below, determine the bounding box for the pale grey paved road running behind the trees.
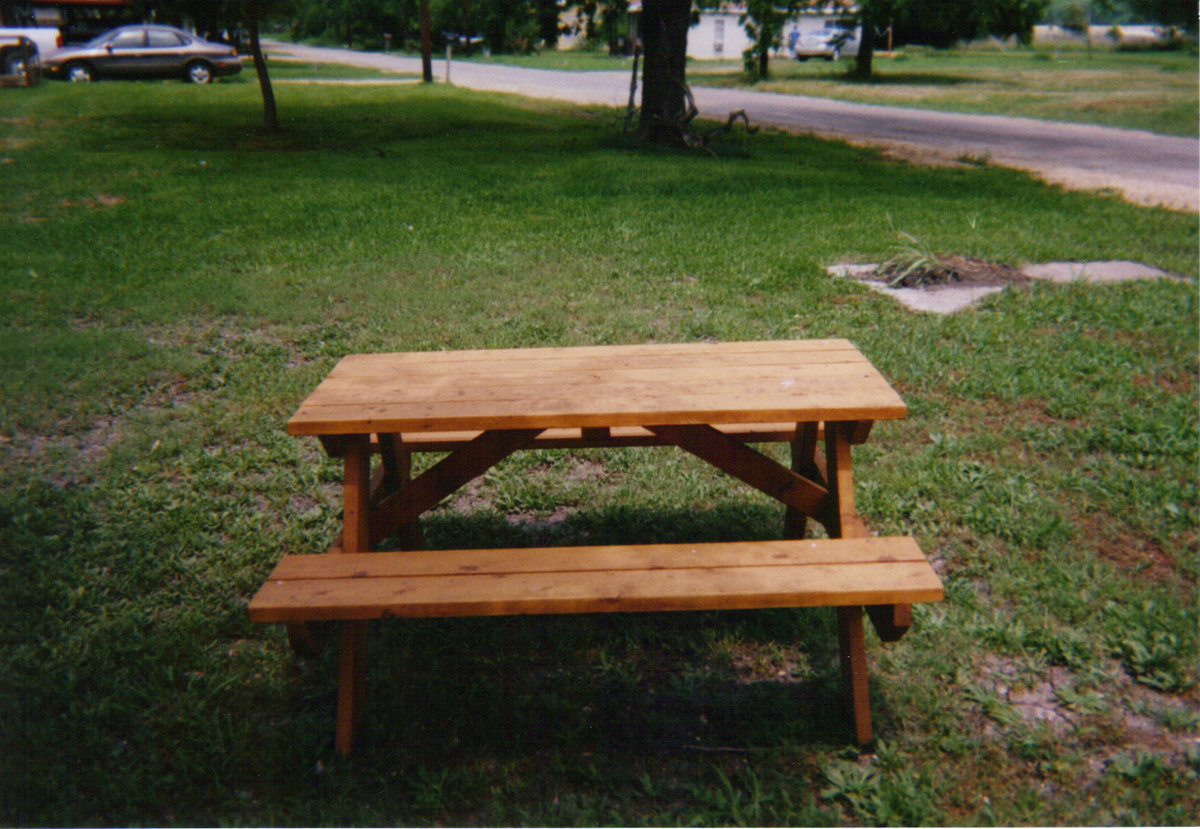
[271,43,1200,212]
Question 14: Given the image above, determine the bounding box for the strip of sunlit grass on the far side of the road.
[689,44,1200,137]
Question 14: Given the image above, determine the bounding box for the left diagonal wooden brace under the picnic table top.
[371,428,542,551]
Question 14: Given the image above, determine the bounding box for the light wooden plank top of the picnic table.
[287,340,906,435]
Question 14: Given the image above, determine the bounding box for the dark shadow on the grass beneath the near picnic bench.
[364,608,868,763]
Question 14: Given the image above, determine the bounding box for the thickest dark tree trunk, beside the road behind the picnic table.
[637,0,691,144]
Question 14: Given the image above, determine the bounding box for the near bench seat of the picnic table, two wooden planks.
[250,537,942,623]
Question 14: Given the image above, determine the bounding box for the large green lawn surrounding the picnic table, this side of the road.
[0,77,1200,825]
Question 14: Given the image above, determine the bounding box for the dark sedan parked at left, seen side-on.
[42,25,241,84]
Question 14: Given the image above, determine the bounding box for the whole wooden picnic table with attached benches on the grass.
[251,340,942,752]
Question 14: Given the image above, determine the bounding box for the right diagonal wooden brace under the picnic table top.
[647,426,829,516]
